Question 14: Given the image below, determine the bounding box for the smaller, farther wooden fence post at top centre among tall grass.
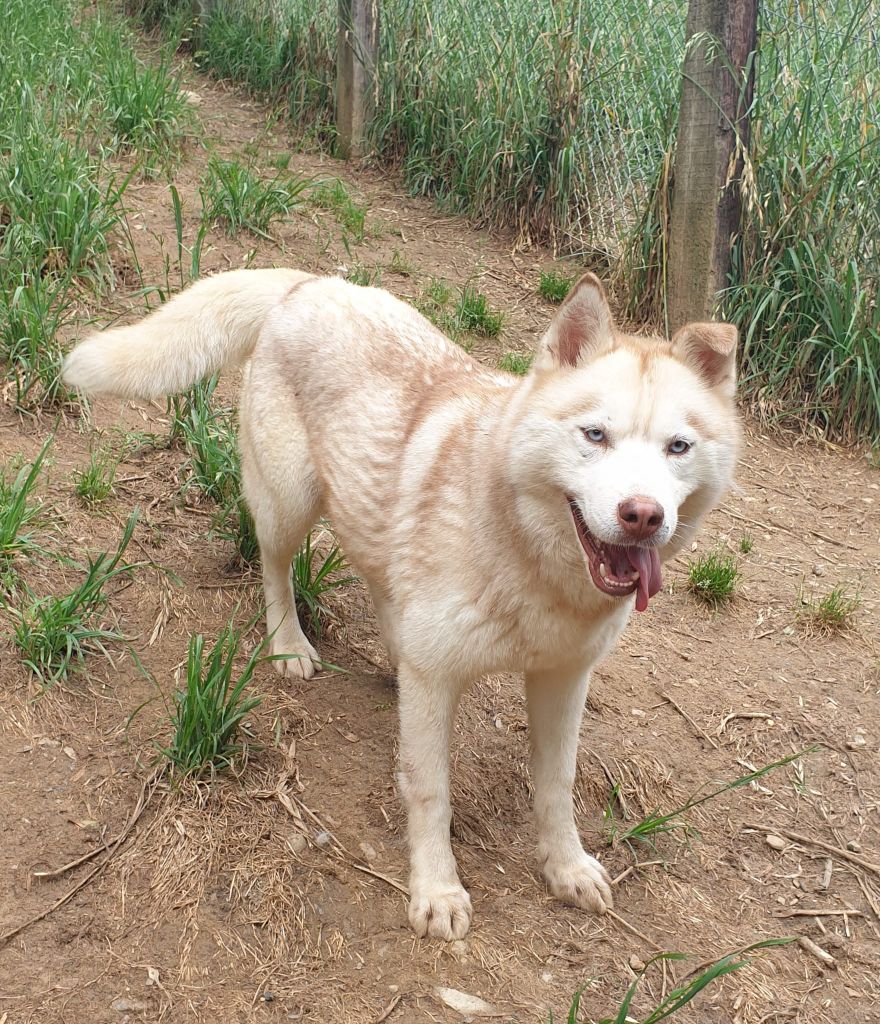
[336,0,379,159]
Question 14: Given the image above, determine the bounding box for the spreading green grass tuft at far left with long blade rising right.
[7,510,137,687]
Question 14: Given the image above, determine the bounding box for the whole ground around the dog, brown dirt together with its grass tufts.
[0,0,880,1024]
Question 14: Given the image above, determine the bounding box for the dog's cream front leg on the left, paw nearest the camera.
[397,662,471,939]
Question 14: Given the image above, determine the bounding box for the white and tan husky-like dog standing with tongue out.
[64,270,740,939]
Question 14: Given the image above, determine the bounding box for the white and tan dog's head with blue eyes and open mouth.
[510,273,740,610]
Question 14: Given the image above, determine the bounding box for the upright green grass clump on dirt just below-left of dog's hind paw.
[162,622,263,778]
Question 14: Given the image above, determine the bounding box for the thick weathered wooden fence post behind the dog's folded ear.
[667,0,758,331]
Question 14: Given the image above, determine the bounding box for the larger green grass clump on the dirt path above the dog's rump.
[199,157,310,241]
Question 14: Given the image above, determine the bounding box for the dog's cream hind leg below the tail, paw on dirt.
[239,368,321,679]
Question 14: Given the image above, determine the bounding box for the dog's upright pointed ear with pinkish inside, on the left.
[535,273,614,370]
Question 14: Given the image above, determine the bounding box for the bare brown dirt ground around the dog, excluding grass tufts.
[0,54,880,1024]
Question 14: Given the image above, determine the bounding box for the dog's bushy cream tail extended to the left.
[61,270,311,398]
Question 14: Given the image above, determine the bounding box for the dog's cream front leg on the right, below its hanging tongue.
[526,667,614,913]
